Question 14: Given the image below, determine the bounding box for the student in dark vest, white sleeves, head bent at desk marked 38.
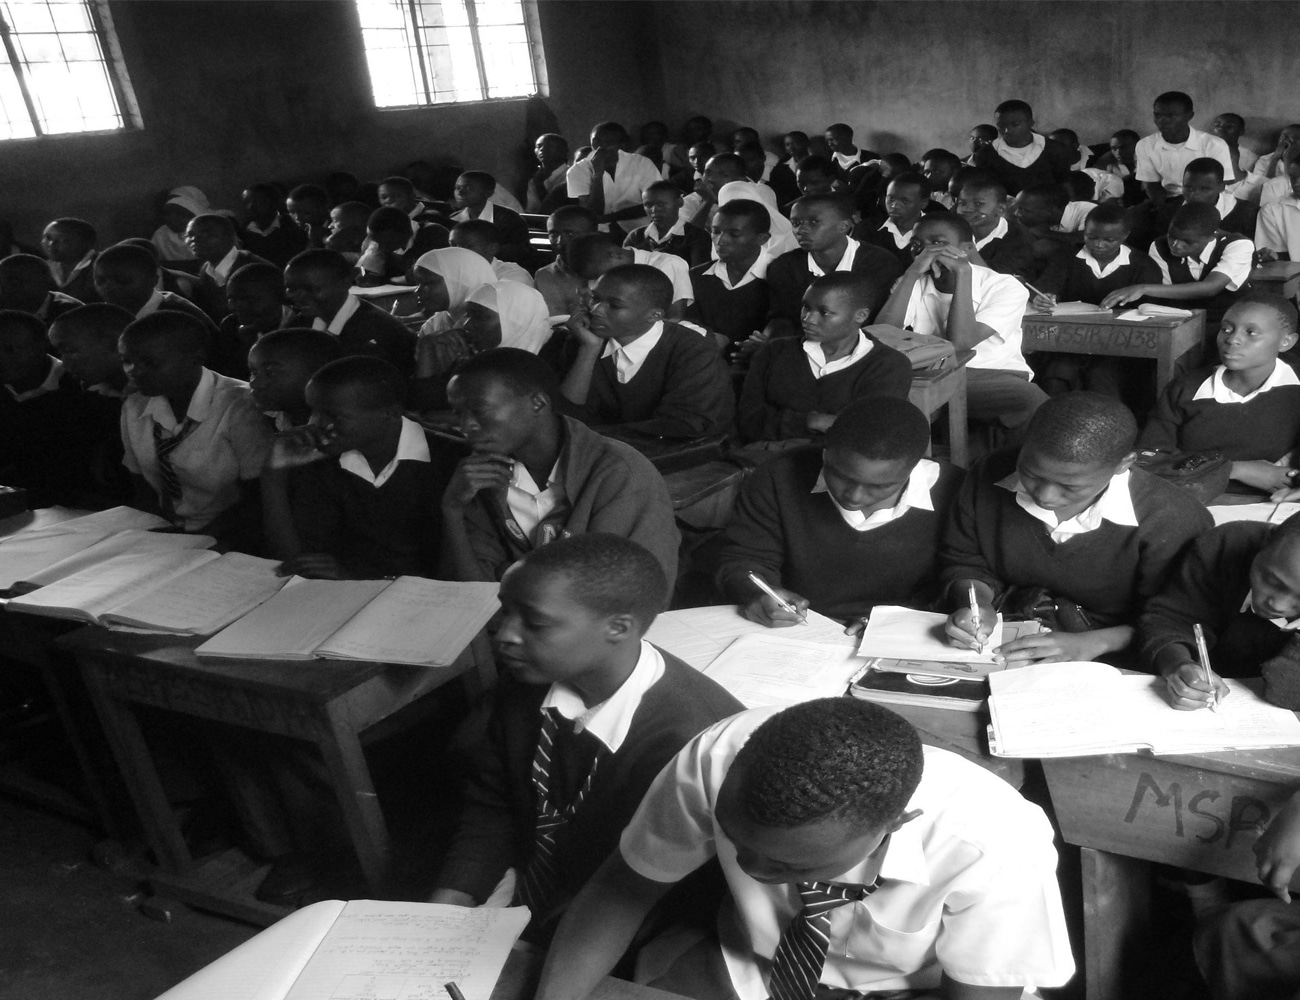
[1101,204,1255,330]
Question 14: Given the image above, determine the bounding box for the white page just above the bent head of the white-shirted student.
[705,628,863,709]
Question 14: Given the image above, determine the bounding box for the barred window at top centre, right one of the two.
[356,0,546,108]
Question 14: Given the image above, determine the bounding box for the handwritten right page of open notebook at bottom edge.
[285,900,529,1000]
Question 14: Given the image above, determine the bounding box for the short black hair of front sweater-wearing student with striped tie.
[517,532,668,632]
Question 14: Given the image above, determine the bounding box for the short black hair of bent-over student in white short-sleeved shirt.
[732,698,926,832]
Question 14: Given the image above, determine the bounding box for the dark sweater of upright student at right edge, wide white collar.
[1138,360,1300,462]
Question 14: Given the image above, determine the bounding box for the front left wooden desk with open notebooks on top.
[59,628,494,922]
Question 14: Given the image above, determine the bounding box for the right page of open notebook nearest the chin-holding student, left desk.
[316,576,501,667]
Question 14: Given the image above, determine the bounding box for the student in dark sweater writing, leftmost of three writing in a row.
[709,397,961,616]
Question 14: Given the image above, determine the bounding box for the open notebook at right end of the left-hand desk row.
[195,576,499,667]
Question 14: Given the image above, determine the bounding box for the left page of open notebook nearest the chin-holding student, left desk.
[195,576,389,659]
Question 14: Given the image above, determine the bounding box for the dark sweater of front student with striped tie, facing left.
[436,653,744,926]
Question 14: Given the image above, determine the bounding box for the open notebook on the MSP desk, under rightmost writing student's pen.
[988,663,1300,757]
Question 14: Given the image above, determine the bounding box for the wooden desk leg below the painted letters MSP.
[1080,848,1151,1000]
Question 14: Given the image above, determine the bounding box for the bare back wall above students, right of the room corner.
[644,0,1300,156]
